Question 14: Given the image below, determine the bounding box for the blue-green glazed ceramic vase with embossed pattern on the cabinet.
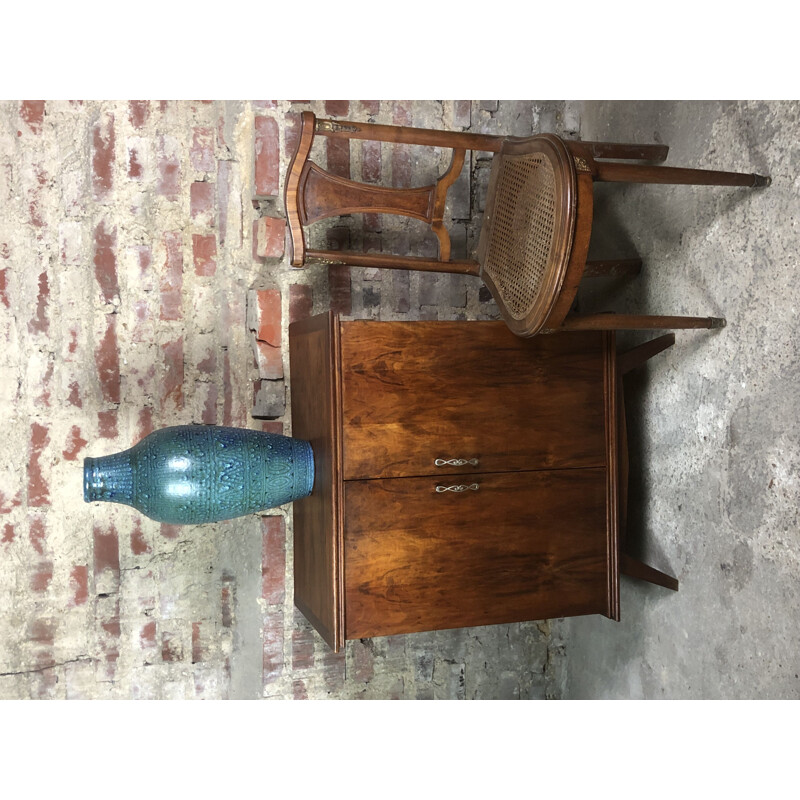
[83,425,314,525]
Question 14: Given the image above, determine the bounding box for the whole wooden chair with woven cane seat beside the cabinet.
[284,111,771,336]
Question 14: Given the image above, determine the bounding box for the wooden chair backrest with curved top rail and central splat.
[284,111,506,275]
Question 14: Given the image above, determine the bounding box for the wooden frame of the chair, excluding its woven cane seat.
[284,111,771,336]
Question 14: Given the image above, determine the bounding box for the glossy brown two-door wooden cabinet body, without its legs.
[289,314,619,650]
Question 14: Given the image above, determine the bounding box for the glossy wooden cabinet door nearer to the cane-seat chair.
[341,322,606,480]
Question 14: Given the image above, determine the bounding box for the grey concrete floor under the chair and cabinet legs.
[553,102,800,699]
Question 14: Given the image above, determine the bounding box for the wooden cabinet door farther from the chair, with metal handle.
[344,469,609,639]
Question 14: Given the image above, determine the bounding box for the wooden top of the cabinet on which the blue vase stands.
[289,315,344,650]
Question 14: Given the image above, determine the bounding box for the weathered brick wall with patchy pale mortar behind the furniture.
[0,101,570,699]
